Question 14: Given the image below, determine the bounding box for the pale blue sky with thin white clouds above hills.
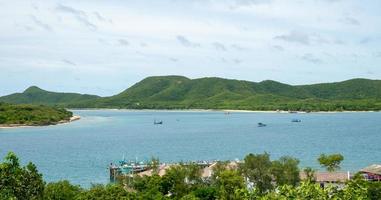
[0,0,381,96]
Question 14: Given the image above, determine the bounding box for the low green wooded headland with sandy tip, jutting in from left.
[0,102,79,128]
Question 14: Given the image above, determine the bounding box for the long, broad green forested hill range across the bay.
[0,76,381,111]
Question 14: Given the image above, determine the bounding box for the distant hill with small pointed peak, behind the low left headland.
[0,86,100,105]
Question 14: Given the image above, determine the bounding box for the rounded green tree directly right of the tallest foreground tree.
[271,156,300,186]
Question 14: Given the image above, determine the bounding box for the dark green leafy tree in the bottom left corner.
[0,152,45,199]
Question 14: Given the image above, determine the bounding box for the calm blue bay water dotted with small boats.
[0,110,381,186]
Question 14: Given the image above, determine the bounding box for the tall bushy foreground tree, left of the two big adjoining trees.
[239,153,273,194]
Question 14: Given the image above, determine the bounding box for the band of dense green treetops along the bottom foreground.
[0,153,381,200]
